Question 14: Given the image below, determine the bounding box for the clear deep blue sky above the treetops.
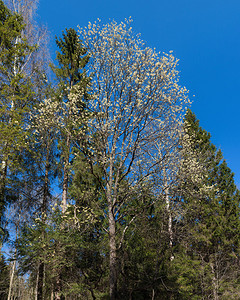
[38,0,240,188]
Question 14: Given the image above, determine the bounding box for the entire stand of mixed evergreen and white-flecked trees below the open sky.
[0,0,240,300]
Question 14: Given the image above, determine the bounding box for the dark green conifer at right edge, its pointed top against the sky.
[174,110,240,299]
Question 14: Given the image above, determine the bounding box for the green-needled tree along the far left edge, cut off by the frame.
[0,1,31,241]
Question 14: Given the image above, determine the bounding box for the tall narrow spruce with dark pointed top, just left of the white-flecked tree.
[53,28,89,211]
